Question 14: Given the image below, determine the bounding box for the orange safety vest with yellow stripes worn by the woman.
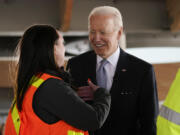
[5,73,89,135]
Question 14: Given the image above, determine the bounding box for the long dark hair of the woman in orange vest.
[14,25,59,111]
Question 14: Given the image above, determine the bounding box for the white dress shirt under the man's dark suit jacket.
[96,47,120,90]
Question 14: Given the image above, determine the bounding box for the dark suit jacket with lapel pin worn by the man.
[67,49,158,135]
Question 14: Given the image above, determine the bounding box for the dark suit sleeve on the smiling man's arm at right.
[139,66,159,135]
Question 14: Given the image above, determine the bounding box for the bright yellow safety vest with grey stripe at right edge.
[157,69,180,135]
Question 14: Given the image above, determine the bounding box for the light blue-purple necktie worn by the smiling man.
[96,59,108,88]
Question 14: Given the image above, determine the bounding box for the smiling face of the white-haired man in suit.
[89,15,121,58]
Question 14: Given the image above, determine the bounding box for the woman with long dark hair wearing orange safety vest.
[5,25,111,135]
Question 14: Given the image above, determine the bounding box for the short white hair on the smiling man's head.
[88,6,123,30]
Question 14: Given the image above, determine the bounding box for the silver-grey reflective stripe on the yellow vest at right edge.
[159,105,180,125]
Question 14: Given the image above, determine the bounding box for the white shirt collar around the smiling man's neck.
[97,47,120,67]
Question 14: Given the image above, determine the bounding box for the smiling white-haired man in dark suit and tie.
[67,6,158,135]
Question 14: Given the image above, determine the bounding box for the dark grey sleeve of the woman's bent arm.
[33,78,111,130]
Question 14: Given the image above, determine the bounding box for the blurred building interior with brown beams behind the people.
[0,0,180,127]
